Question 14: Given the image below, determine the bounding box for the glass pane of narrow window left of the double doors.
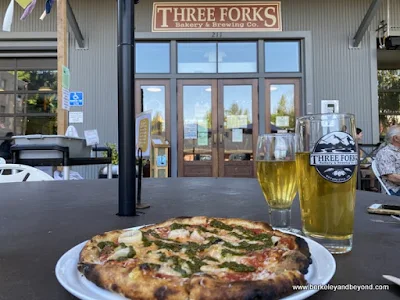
[141,85,165,138]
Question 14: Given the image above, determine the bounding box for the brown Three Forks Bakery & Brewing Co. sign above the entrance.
[152,1,282,32]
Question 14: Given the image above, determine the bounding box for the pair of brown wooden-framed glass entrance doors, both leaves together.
[178,80,258,177]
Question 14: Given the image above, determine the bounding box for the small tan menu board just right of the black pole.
[136,111,151,157]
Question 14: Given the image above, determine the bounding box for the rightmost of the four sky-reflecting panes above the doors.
[265,41,300,72]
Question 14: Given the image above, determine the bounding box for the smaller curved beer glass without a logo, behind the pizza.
[256,133,297,231]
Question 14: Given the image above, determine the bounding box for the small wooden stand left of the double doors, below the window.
[150,139,170,178]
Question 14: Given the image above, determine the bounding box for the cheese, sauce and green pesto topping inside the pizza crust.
[90,219,294,281]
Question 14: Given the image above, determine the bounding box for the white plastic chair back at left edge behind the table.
[0,164,54,183]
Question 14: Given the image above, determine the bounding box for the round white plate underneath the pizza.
[56,226,336,300]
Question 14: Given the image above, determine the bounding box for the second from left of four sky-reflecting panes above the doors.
[178,43,217,73]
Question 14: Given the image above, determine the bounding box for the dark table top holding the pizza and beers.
[0,178,400,300]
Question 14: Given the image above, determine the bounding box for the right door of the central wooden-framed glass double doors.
[218,79,258,177]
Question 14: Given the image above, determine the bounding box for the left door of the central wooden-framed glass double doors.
[178,80,218,177]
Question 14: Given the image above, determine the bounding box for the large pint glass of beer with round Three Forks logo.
[296,114,358,253]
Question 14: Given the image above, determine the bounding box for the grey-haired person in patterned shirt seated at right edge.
[376,125,400,196]
